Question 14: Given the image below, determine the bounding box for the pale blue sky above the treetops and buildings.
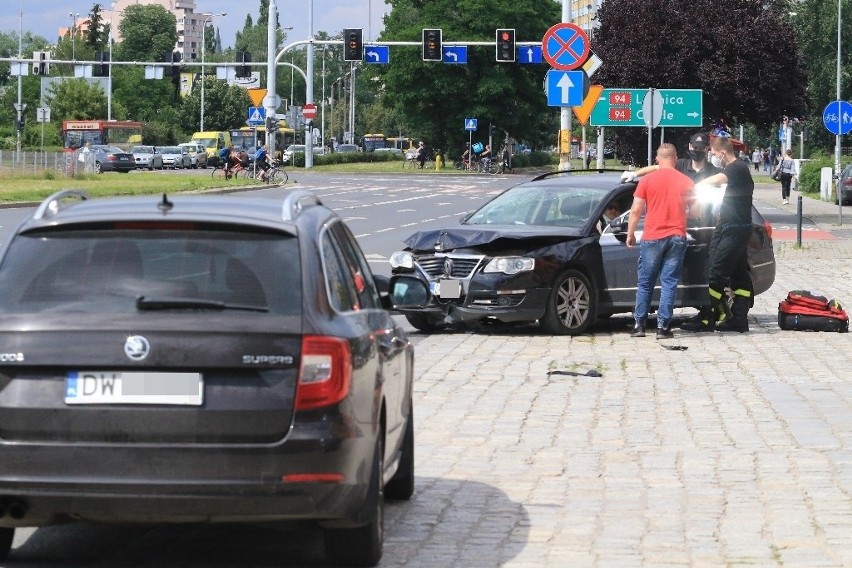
[0,0,390,48]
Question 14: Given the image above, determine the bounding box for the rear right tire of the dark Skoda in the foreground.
[324,434,385,566]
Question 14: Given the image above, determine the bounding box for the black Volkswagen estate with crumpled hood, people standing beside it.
[390,172,775,335]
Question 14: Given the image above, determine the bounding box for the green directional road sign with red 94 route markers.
[589,89,703,127]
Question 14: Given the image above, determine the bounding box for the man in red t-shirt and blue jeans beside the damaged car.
[627,143,695,339]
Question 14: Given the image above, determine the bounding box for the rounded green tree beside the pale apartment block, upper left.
[115,4,177,61]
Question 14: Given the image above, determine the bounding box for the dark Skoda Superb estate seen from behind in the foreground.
[0,190,414,566]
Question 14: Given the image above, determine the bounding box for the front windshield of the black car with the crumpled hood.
[464,184,610,228]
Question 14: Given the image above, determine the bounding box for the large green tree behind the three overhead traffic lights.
[370,0,561,155]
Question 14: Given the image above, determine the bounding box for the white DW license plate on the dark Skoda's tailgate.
[65,371,204,406]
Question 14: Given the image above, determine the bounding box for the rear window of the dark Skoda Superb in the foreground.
[0,229,301,315]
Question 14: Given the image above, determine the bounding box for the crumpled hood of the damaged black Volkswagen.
[403,225,583,251]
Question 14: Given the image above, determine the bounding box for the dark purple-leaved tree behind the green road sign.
[592,0,808,162]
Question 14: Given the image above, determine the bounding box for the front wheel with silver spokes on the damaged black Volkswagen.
[541,268,597,335]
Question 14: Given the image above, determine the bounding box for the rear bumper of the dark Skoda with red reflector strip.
[0,424,375,527]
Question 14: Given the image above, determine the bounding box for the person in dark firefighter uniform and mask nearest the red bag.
[680,138,754,332]
